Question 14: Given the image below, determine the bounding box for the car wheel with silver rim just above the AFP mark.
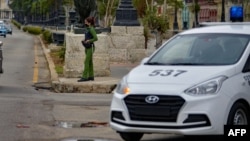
[227,102,250,125]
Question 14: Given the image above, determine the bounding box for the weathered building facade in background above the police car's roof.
[158,0,250,30]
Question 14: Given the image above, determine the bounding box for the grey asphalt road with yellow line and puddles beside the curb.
[0,23,223,141]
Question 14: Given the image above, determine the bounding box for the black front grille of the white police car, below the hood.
[124,95,185,122]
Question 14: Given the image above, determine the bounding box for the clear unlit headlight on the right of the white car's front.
[184,76,227,95]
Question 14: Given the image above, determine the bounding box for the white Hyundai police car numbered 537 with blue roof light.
[110,24,250,141]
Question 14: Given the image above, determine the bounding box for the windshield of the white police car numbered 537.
[147,33,250,65]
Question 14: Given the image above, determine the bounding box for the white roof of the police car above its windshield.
[180,23,250,35]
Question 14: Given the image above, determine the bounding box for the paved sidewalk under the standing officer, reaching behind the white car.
[39,38,138,94]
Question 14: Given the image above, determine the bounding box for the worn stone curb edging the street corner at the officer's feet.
[38,36,120,94]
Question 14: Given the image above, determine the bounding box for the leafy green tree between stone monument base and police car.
[133,0,183,48]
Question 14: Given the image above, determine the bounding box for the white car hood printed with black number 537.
[127,65,235,85]
